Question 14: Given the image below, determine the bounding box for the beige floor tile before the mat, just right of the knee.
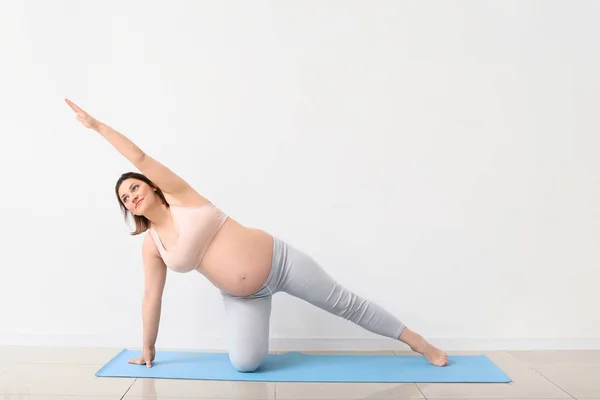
[275,382,424,400]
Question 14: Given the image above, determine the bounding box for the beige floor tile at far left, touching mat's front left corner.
[0,364,134,396]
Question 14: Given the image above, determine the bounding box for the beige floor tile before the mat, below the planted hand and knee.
[127,378,275,400]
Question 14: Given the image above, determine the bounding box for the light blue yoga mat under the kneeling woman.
[96,349,511,383]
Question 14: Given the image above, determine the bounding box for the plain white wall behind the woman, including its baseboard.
[0,0,600,349]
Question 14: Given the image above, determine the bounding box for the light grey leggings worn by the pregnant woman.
[221,238,404,372]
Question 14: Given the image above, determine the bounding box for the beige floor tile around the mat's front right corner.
[417,368,571,399]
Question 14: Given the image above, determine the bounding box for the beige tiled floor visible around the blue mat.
[0,346,600,400]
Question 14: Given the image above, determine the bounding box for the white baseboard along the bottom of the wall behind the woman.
[0,331,600,351]
